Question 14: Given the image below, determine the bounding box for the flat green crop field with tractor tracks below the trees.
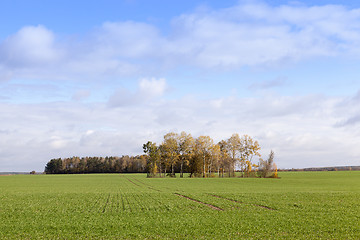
[0,171,360,239]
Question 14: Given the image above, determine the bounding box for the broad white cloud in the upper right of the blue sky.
[167,3,360,68]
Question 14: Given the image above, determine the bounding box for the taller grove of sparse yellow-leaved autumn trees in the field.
[143,132,277,177]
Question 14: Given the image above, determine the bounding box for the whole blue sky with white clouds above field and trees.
[0,0,360,172]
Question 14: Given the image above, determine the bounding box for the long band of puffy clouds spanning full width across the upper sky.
[0,2,360,80]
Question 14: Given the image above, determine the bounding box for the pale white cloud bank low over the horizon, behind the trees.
[0,91,360,171]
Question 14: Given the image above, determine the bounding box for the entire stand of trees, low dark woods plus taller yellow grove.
[45,132,277,178]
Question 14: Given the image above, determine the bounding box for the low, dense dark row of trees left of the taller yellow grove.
[45,155,147,174]
